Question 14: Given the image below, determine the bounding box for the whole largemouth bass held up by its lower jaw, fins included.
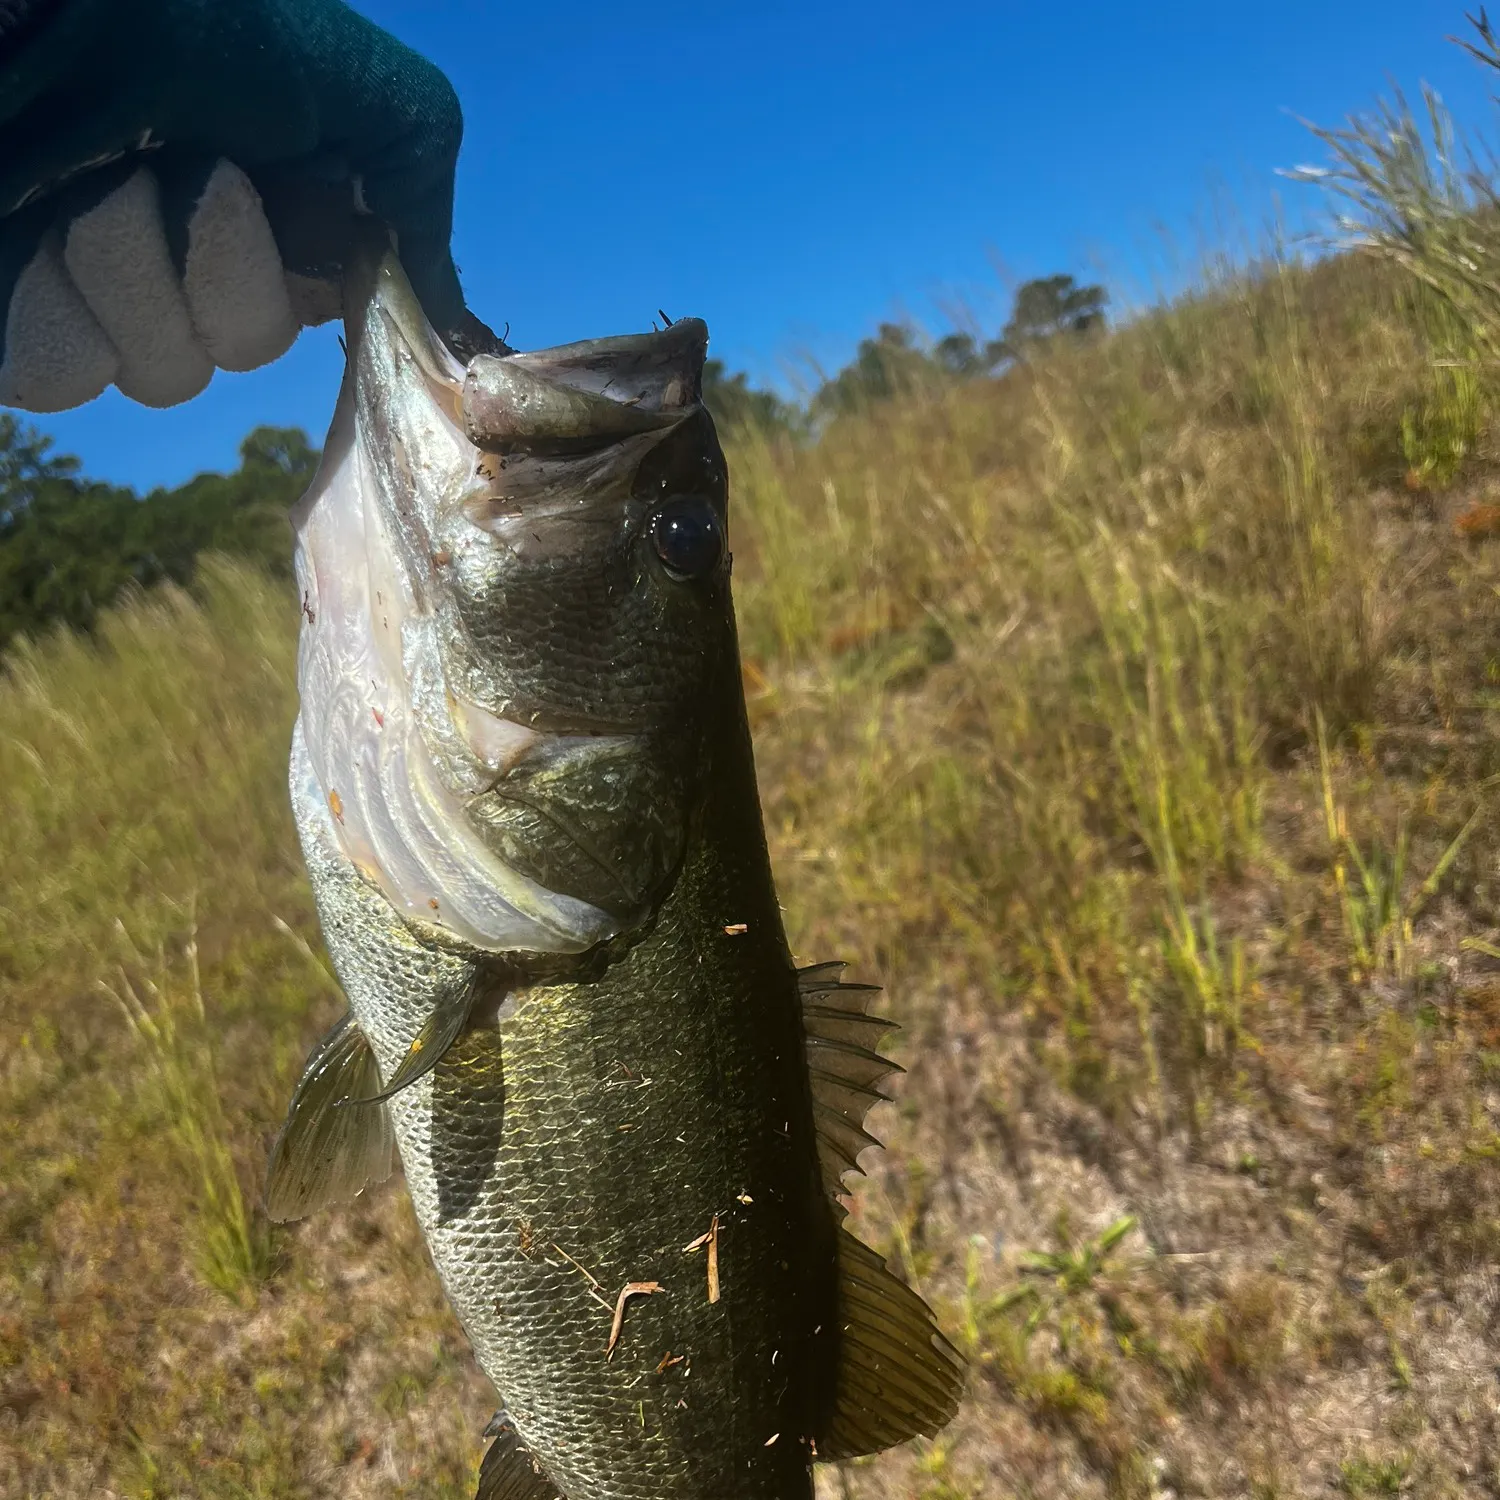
[267,254,962,1500]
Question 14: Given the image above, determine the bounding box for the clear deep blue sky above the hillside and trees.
[20,0,1500,489]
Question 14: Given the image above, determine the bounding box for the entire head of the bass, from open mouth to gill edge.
[294,254,738,953]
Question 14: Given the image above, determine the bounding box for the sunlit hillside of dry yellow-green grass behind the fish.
[14,219,1500,1500]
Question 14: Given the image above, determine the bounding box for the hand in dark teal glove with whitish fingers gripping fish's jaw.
[0,0,494,411]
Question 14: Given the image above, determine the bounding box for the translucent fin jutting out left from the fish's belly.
[266,1014,396,1224]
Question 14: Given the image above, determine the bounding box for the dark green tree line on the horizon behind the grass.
[0,276,1106,650]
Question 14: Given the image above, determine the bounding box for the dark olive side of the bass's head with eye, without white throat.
[443,320,735,921]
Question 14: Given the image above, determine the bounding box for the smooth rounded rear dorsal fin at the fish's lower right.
[816,1230,965,1461]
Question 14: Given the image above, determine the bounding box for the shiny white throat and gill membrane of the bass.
[293,282,618,953]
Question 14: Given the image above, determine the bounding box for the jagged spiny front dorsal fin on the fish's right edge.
[797,962,902,1197]
